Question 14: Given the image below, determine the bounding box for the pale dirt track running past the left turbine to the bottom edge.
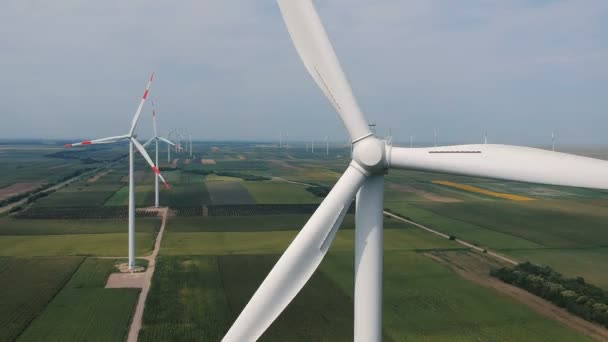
[127,208,169,342]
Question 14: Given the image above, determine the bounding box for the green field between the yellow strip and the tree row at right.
[386,191,608,288]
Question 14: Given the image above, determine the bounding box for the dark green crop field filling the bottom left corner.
[0,257,82,341]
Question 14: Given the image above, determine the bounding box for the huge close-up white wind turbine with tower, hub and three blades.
[223,0,608,342]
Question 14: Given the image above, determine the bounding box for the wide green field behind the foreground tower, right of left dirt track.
[140,251,587,341]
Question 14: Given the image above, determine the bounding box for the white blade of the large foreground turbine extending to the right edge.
[390,144,608,189]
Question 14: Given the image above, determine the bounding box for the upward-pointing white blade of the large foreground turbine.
[278,0,371,141]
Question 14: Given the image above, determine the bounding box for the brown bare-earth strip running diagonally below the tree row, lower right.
[425,253,608,341]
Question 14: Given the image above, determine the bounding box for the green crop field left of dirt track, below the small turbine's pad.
[18,258,139,341]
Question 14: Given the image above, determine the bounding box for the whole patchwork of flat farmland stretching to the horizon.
[0,141,608,341]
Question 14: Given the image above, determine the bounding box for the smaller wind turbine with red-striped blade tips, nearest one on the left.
[65,73,169,270]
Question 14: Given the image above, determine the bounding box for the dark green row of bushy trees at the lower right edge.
[490,262,608,327]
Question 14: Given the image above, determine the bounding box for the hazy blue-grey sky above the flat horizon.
[0,0,608,145]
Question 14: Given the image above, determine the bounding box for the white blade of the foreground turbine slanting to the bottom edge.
[222,166,366,342]
